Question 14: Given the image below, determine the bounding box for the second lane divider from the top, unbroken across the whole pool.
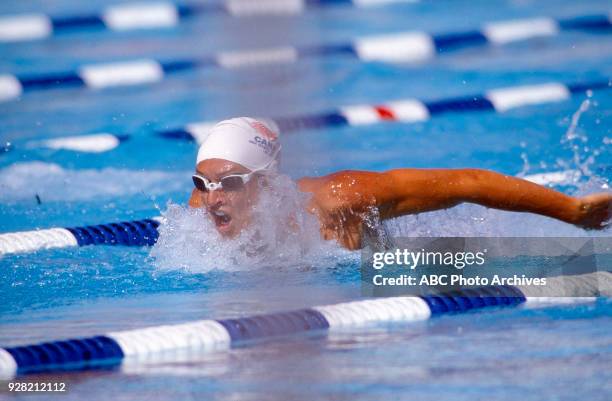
[0,15,612,101]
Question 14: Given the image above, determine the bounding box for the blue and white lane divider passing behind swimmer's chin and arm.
[0,170,596,257]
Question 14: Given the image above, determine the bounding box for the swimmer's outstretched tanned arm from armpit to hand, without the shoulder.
[382,169,612,229]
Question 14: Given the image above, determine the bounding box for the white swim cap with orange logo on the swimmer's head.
[196,117,280,171]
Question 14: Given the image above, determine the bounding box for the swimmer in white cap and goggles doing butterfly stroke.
[189,117,612,249]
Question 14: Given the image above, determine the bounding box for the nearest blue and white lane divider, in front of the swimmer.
[0,272,612,378]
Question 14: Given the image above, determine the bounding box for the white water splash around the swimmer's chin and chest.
[150,175,358,273]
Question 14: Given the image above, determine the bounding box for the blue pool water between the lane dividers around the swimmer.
[0,0,612,400]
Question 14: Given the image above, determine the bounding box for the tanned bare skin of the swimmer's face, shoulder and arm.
[189,159,612,249]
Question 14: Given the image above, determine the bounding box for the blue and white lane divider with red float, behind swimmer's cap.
[17,80,611,153]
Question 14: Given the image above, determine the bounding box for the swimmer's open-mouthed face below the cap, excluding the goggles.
[196,159,258,238]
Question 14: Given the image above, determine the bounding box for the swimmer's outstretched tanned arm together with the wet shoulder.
[302,169,612,228]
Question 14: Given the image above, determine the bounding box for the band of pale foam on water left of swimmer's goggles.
[0,162,189,202]
